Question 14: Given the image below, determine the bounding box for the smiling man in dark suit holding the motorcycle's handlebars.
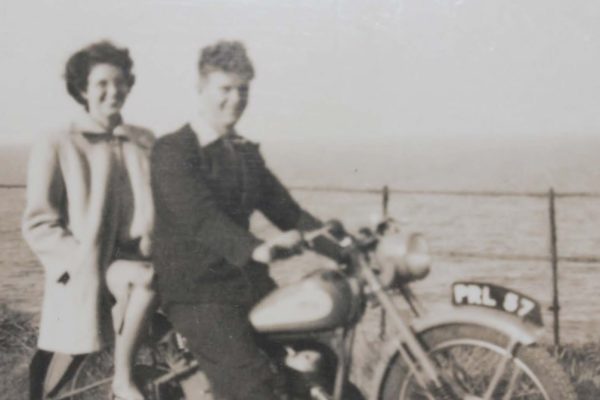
[151,41,338,399]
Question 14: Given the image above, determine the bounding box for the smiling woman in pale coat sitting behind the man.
[23,42,154,400]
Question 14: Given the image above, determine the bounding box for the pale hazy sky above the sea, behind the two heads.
[0,0,600,144]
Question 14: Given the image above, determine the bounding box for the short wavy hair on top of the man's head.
[198,40,254,80]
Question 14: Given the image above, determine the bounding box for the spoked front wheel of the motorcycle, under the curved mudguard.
[376,325,576,400]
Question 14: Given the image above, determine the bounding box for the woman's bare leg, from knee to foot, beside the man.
[107,260,156,400]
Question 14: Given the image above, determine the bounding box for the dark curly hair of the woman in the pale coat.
[65,40,135,109]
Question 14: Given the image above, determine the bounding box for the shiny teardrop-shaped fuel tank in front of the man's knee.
[250,270,358,333]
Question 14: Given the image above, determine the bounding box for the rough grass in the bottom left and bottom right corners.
[0,305,600,400]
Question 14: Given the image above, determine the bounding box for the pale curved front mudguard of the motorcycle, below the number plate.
[369,306,543,399]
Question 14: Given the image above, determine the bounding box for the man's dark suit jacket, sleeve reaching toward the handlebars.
[151,125,321,306]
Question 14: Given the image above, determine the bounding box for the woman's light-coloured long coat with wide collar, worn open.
[23,114,154,354]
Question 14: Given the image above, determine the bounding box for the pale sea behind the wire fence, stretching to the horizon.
[0,134,600,343]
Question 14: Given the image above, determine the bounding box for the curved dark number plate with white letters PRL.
[452,282,543,326]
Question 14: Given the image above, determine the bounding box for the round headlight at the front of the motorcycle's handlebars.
[375,230,431,286]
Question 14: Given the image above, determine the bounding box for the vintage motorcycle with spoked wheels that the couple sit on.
[47,220,576,400]
